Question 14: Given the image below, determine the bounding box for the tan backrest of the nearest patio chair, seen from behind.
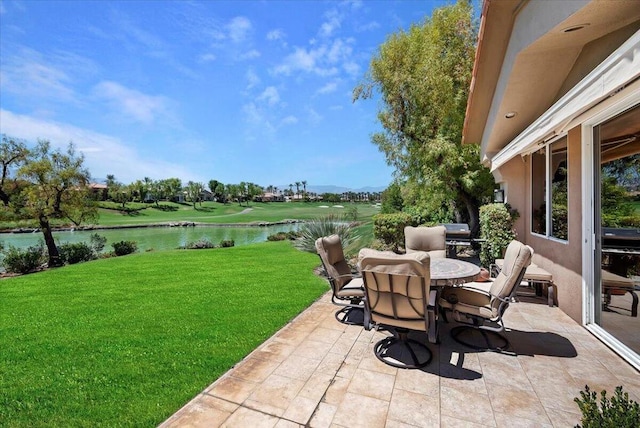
[360,251,431,331]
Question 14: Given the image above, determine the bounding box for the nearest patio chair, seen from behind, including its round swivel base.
[361,251,436,368]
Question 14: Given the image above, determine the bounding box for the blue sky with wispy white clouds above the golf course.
[0,0,448,189]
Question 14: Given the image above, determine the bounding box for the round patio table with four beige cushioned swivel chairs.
[315,225,533,368]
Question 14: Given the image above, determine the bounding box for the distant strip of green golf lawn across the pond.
[98,202,379,226]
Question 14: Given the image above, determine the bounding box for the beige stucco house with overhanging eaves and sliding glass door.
[463,0,640,368]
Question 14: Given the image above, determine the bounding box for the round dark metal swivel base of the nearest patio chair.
[373,330,432,369]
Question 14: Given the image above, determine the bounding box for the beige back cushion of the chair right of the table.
[490,240,533,304]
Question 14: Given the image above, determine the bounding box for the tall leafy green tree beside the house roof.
[353,0,495,236]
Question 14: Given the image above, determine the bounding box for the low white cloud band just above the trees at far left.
[0,109,192,183]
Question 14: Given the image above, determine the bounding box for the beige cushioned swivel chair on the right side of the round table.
[439,240,533,351]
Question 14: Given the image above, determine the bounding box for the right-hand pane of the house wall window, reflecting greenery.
[550,137,569,240]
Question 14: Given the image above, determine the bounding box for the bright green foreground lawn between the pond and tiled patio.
[0,242,328,427]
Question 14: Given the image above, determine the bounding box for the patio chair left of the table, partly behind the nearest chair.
[315,235,368,325]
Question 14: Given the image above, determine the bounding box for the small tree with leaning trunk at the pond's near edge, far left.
[18,140,97,267]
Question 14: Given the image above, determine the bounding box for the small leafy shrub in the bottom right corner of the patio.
[573,385,640,428]
